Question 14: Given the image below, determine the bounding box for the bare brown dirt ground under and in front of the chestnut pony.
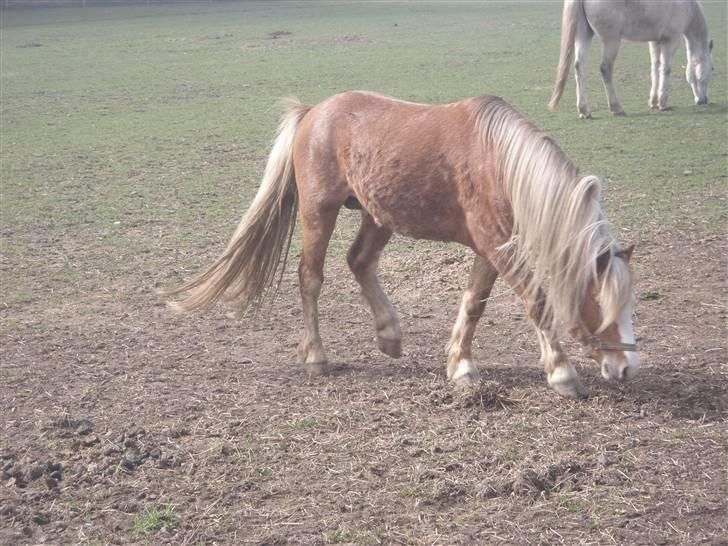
[0,220,728,544]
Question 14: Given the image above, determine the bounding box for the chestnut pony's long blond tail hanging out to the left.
[164,100,312,316]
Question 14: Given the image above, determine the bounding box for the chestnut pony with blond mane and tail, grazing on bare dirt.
[168,92,639,398]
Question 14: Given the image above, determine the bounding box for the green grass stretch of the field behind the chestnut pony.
[2,2,728,247]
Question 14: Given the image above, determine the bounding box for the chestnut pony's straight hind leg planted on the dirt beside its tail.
[298,202,338,374]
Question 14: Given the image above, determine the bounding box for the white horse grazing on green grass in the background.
[549,0,713,118]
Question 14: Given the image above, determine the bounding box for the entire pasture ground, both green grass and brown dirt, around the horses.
[0,1,728,545]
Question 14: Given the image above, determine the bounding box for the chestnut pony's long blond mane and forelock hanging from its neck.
[477,97,631,329]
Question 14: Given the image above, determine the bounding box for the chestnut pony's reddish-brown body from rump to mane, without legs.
[295,91,500,243]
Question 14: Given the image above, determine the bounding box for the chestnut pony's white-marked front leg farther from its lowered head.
[447,255,498,385]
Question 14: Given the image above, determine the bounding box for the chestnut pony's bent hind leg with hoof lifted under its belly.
[347,211,402,358]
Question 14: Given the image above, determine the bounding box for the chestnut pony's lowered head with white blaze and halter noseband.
[572,245,640,381]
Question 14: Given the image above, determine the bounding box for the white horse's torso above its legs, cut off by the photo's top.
[584,0,693,42]
